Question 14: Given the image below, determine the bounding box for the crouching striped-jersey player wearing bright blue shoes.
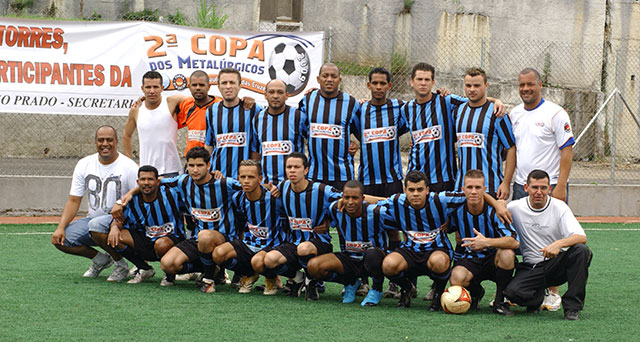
[307,180,387,306]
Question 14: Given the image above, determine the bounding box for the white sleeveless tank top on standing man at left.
[137,97,181,175]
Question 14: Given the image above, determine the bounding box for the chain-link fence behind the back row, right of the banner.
[326,29,640,184]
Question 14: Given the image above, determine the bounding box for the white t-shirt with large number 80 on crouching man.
[69,153,138,218]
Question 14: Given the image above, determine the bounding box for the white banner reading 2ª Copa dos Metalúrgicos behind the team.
[0,18,324,115]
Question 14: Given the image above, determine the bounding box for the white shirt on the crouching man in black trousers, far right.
[507,196,586,264]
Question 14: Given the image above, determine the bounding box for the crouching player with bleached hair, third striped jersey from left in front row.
[213,159,286,295]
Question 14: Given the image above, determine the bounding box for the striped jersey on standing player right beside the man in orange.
[205,100,262,178]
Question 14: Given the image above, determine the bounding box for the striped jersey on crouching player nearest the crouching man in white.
[449,202,518,260]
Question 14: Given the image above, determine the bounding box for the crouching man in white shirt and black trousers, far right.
[504,170,592,320]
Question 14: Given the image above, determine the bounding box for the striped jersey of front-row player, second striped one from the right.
[378,192,466,252]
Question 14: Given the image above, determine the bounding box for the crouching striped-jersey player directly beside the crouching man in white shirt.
[449,170,519,316]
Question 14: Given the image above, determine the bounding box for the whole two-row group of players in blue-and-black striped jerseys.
[53,63,592,315]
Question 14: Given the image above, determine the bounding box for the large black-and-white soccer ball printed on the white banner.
[269,43,311,96]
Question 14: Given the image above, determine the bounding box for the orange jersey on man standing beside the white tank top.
[178,97,222,156]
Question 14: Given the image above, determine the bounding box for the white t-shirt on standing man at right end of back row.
[509,99,574,184]
